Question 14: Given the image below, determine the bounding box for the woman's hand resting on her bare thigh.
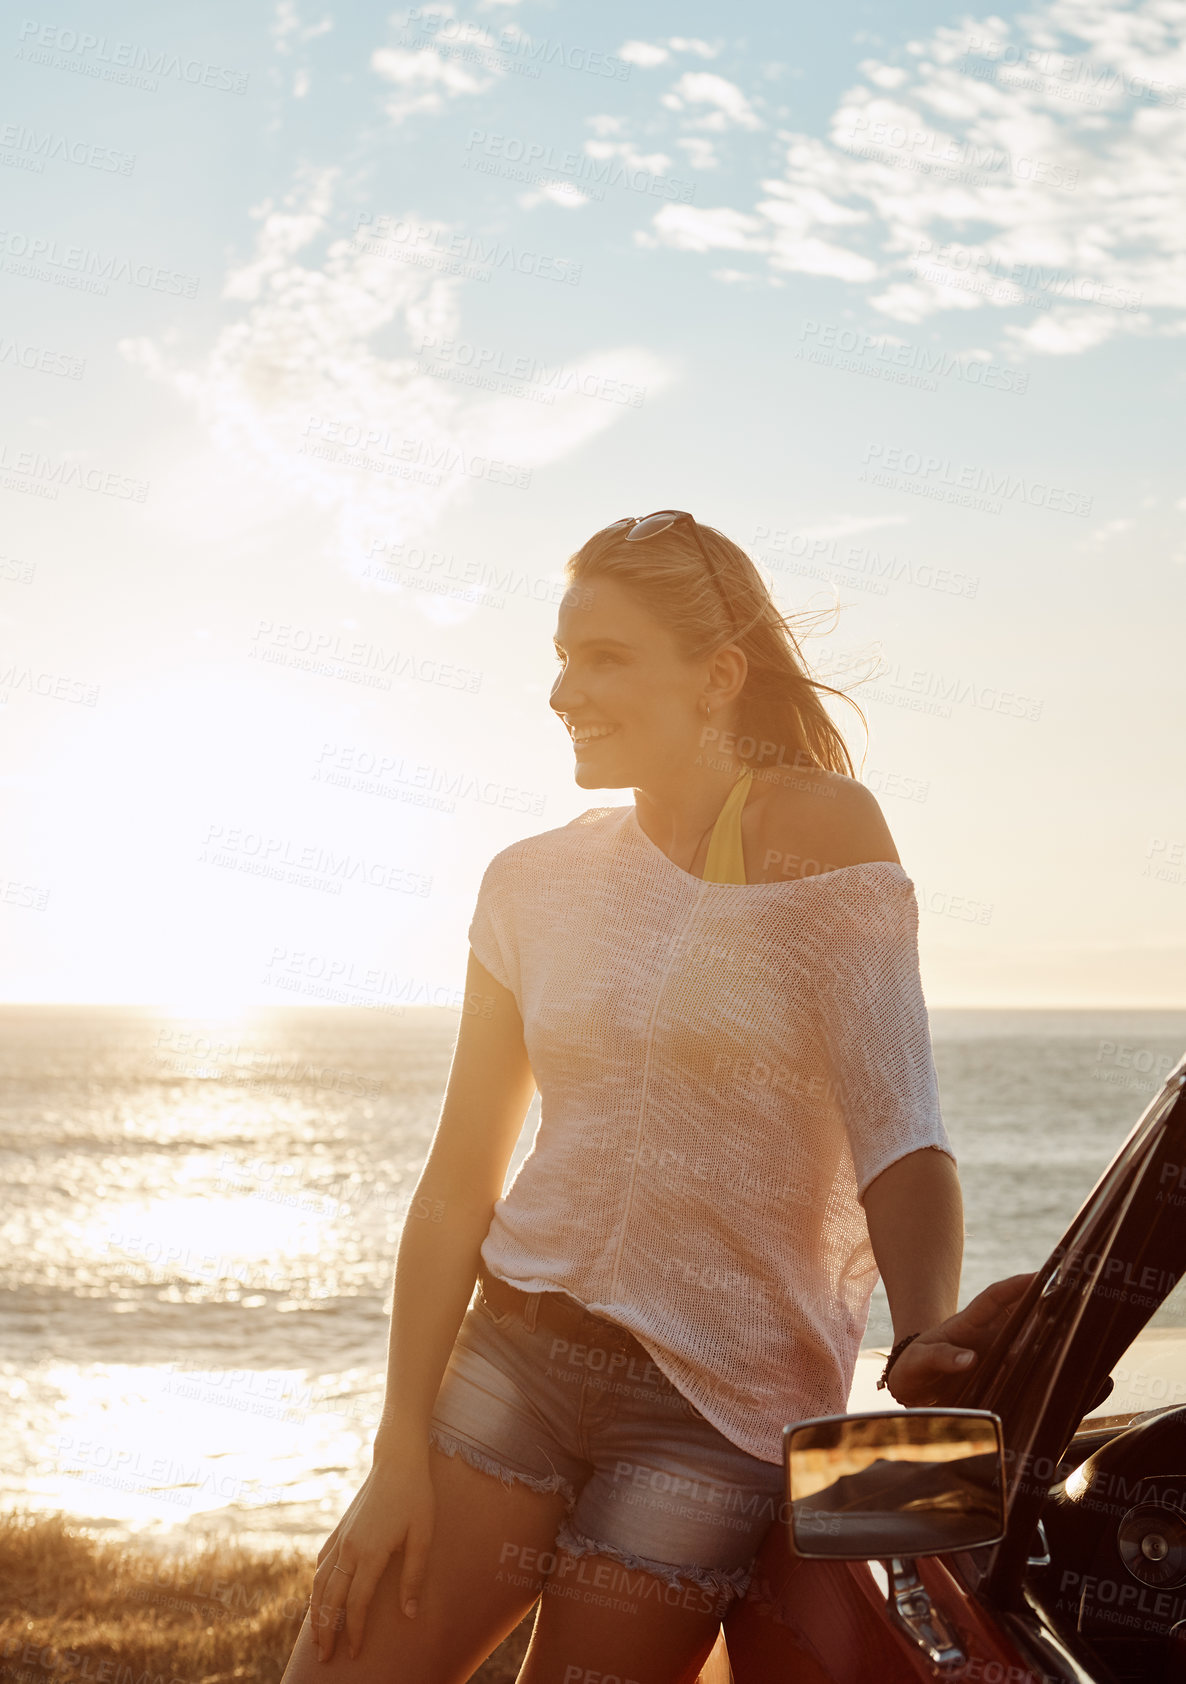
[310,1448,435,1660]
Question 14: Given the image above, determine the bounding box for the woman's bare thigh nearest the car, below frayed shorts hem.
[517,1548,721,1684]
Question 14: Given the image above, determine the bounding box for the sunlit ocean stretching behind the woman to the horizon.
[0,1005,1186,1548]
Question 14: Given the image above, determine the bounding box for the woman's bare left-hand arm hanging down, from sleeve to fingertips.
[310,950,536,1657]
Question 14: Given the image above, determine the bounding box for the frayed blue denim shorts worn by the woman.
[430,1280,785,1617]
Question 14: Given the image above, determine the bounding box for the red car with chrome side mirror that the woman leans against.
[724,1058,1186,1684]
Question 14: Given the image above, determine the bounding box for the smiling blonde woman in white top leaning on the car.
[285,510,1031,1684]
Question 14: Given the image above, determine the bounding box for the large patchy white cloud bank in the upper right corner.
[652,0,1186,355]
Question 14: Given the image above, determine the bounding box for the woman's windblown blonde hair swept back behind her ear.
[564,520,868,776]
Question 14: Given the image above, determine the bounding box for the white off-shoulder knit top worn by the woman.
[468,805,954,1462]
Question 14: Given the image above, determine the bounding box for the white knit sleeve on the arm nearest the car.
[820,871,955,1199]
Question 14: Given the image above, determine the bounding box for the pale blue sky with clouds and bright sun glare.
[0,0,1186,1010]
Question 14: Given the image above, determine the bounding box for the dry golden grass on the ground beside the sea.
[0,1514,532,1684]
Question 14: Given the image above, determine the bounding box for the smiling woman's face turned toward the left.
[549,578,721,790]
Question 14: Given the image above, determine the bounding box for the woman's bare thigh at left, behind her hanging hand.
[281,1448,566,1684]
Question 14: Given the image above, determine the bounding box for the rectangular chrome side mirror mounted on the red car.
[782,1410,1004,1561]
